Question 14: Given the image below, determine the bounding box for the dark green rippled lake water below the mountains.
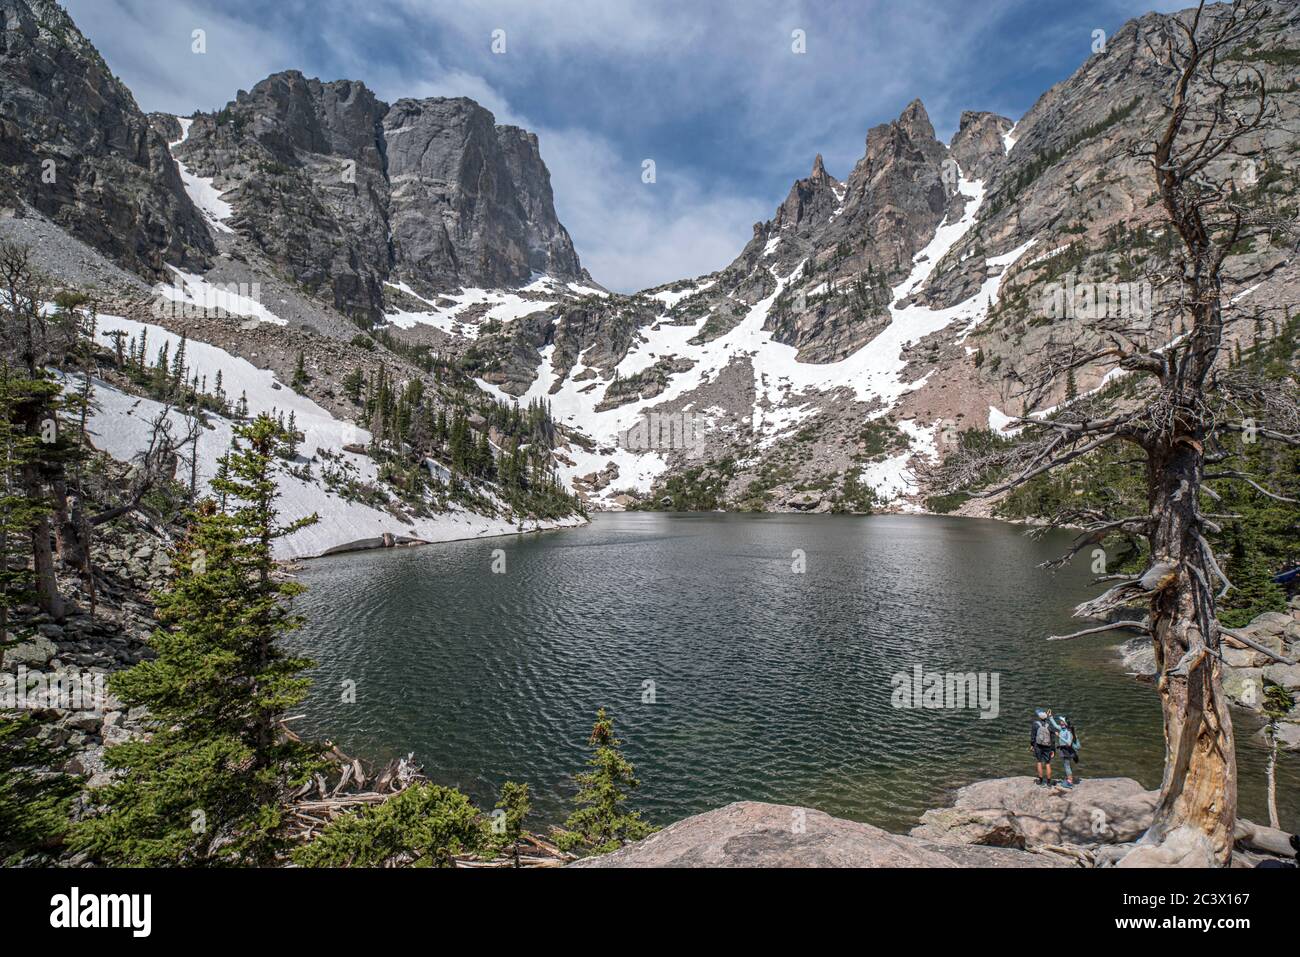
[294,514,1300,831]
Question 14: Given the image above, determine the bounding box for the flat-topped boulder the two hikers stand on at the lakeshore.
[911,776,1157,849]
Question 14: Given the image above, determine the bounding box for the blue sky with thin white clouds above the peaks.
[62,0,1188,291]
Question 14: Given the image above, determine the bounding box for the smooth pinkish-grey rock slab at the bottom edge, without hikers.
[571,801,1069,867]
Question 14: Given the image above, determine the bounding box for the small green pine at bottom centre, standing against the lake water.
[556,707,655,854]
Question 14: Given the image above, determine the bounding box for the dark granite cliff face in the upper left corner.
[0,0,215,278]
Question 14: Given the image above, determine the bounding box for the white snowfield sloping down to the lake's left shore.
[67,316,584,559]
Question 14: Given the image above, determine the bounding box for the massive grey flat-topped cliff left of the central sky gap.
[176,70,586,325]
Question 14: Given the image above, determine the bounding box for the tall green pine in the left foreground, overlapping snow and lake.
[73,415,316,866]
